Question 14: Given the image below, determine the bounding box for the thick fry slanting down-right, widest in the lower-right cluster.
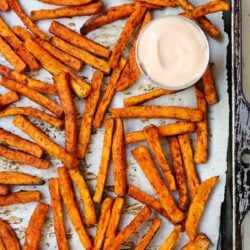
[132,146,185,223]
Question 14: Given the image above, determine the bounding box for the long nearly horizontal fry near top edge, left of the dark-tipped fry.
[30,2,103,21]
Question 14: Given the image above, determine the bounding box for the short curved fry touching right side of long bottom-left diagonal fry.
[69,168,96,225]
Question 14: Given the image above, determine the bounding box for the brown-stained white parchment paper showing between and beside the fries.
[0,0,229,249]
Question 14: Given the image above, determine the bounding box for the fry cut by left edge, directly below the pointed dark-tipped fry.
[0,191,41,206]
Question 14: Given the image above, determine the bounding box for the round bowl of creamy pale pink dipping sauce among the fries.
[137,16,209,90]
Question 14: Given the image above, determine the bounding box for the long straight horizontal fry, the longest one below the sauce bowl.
[112,106,203,122]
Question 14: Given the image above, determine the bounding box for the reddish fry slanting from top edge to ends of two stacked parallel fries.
[109,3,146,69]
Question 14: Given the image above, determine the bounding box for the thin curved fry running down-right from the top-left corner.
[8,0,49,40]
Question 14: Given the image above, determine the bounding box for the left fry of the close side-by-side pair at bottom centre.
[93,197,113,250]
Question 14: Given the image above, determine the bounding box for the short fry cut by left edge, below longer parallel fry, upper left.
[0,37,26,72]
